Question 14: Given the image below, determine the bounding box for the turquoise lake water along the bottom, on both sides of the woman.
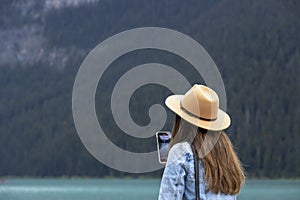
[0,179,300,200]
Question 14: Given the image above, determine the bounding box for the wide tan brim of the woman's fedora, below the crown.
[165,95,231,131]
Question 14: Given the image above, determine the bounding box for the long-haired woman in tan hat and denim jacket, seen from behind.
[159,85,245,200]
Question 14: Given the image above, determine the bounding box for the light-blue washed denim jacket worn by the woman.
[158,142,236,200]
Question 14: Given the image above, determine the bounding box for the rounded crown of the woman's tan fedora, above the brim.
[181,84,219,120]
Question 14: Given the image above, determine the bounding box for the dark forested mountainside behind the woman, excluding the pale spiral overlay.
[0,0,300,178]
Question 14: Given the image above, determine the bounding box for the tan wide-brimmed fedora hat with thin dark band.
[165,84,230,131]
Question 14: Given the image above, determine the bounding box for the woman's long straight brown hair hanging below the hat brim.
[170,115,245,195]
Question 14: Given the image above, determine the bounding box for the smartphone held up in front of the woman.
[156,131,172,164]
